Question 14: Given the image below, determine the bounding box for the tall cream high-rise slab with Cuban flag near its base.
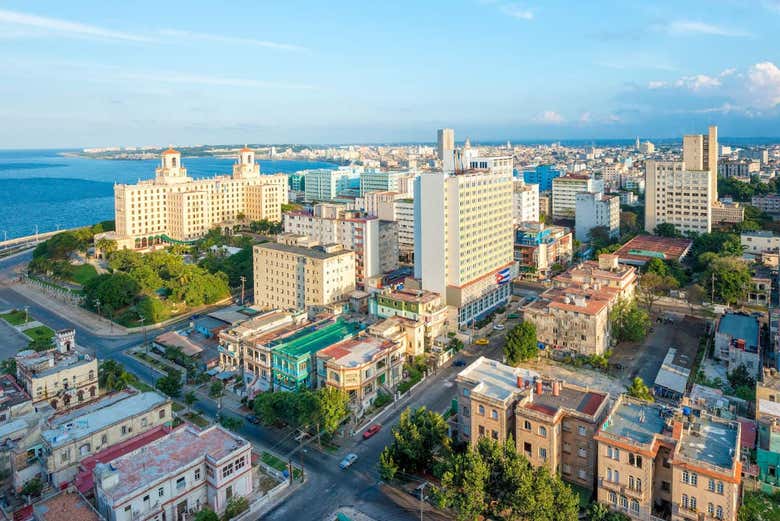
[414,167,514,325]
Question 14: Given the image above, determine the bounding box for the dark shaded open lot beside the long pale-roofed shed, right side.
[609,315,705,386]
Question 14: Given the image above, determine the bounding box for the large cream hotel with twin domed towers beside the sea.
[111,147,287,248]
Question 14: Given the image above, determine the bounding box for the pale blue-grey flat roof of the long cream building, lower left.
[41,392,168,447]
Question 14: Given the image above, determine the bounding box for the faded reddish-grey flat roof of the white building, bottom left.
[96,424,249,500]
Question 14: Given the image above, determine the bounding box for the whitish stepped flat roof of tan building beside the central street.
[457,356,541,402]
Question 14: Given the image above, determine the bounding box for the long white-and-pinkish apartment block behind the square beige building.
[283,204,398,287]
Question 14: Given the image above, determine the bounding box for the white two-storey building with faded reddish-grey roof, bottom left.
[94,424,253,521]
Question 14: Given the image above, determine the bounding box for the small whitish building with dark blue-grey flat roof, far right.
[715,313,762,379]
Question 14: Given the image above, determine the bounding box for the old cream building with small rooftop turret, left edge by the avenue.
[16,329,98,409]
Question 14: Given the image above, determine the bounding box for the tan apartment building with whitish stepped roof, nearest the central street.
[455,356,540,445]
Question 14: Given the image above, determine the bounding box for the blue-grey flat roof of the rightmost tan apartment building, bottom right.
[679,415,739,469]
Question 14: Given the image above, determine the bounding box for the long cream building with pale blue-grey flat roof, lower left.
[41,391,173,487]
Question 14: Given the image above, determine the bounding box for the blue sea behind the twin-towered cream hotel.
[0,150,336,240]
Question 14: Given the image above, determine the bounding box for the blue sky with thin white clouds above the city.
[0,0,780,148]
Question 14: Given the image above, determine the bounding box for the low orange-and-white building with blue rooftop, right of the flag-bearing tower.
[514,222,573,278]
